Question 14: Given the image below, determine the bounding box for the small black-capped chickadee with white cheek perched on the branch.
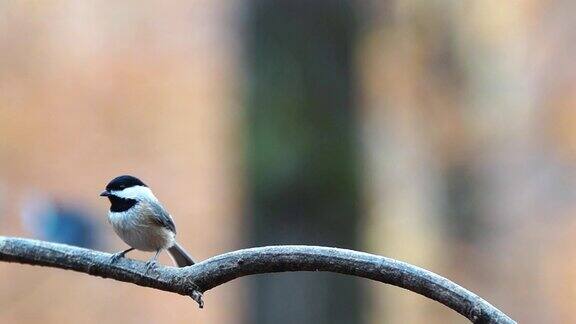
[100,175,194,272]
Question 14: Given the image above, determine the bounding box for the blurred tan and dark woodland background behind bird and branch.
[0,0,576,324]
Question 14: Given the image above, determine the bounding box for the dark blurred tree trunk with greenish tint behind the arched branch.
[246,0,362,324]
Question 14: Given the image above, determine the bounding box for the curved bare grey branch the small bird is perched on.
[0,236,516,323]
